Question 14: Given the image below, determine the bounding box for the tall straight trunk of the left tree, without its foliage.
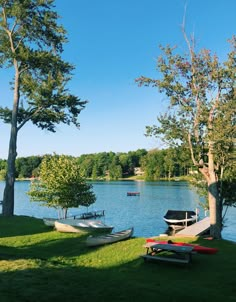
[2,67,20,216]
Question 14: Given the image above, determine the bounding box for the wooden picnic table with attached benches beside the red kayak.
[142,242,194,263]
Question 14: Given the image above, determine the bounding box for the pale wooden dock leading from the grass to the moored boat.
[175,217,210,237]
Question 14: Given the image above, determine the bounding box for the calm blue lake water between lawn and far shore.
[0,181,236,241]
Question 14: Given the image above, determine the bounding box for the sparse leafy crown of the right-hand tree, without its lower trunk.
[136,37,236,162]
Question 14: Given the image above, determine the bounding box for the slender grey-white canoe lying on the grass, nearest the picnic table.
[86,228,134,246]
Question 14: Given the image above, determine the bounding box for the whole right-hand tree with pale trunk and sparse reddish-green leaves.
[136,25,236,238]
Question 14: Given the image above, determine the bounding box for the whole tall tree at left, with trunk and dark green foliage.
[0,0,86,216]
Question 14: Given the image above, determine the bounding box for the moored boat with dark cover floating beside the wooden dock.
[163,210,198,226]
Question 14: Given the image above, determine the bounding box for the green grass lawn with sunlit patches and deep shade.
[0,216,236,302]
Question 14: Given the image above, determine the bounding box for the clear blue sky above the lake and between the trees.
[0,0,236,158]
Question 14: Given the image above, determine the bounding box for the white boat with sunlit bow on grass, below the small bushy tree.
[54,219,114,234]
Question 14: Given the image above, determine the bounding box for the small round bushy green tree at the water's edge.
[28,155,96,218]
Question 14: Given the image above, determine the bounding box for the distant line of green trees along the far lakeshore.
[0,147,192,180]
